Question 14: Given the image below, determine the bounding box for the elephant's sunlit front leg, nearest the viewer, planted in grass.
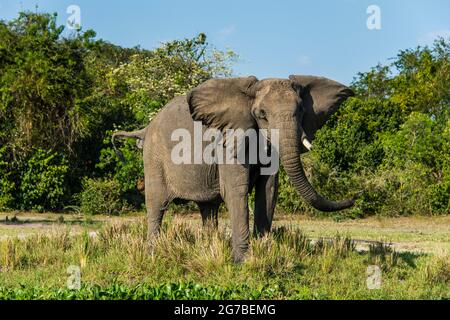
[219,164,250,263]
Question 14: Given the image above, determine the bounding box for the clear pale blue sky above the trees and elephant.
[0,0,450,84]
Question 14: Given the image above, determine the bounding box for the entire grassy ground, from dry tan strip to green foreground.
[0,213,450,299]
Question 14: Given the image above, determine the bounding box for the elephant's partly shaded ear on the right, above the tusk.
[289,75,354,140]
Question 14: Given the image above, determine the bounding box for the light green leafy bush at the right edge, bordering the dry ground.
[383,112,450,214]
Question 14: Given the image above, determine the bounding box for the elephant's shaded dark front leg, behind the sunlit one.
[253,173,278,236]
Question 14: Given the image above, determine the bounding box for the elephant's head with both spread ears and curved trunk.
[187,76,354,211]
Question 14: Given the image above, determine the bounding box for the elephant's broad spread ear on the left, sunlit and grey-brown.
[187,77,258,130]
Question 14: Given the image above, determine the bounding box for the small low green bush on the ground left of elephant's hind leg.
[79,179,125,215]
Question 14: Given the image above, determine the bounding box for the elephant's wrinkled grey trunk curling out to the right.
[277,115,354,212]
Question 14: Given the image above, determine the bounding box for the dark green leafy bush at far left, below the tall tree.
[20,149,69,211]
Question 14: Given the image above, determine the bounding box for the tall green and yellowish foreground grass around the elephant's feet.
[0,216,450,299]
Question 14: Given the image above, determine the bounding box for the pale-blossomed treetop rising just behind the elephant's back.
[111,33,236,124]
